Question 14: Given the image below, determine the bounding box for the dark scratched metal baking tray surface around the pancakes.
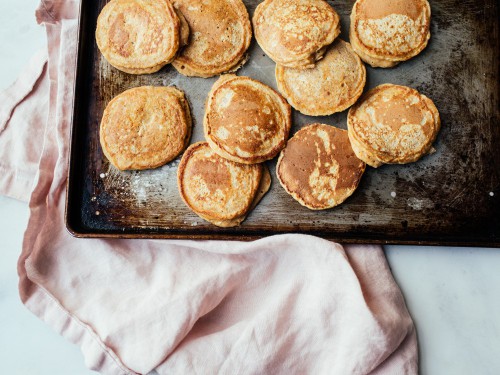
[67,0,500,246]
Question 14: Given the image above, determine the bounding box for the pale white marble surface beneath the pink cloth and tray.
[0,0,500,375]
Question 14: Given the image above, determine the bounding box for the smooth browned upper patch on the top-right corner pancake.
[359,0,422,20]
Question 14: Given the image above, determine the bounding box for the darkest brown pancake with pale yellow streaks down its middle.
[276,124,365,210]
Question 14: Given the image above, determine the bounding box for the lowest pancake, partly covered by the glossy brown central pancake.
[177,142,271,227]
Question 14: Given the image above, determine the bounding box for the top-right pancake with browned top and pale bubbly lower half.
[350,0,431,68]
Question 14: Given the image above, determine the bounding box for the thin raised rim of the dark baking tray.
[64,0,500,248]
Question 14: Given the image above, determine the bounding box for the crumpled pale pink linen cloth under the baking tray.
[0,1,418,375]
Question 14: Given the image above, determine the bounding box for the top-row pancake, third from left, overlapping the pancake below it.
[252,0,340,69]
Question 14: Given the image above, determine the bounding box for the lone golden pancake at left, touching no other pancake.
[99,86,191,170]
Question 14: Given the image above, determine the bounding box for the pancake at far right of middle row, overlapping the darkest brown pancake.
[347,84,441,167]
